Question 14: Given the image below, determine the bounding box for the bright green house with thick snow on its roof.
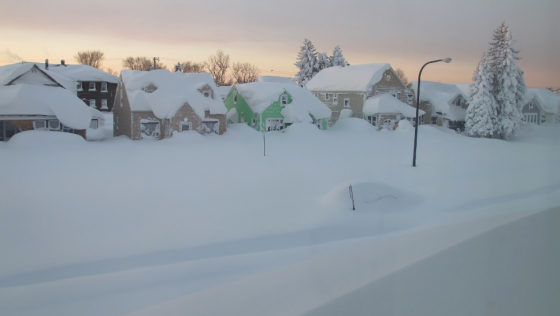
[225,82,331,131]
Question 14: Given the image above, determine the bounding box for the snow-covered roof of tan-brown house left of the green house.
[121,69,227,119]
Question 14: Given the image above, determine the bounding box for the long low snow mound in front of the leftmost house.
[8,130,86,148]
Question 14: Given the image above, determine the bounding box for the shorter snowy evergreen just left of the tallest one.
[465,54,496,137]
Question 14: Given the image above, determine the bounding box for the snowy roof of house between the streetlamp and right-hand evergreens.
[410,81,468,121]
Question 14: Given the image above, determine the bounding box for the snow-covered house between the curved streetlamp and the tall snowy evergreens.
[409,81,468,130]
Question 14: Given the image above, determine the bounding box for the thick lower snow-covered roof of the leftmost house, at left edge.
[0,84,92,129]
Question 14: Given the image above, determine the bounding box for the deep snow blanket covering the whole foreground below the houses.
[0,115,560,315]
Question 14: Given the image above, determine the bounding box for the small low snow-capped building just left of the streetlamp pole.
[363,93,425,129]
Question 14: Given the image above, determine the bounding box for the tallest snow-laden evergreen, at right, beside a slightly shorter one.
[488,22,527,139]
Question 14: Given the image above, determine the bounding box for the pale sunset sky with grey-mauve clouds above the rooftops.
[0,0,560,88]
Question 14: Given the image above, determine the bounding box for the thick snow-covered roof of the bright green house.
[235,82,331,122]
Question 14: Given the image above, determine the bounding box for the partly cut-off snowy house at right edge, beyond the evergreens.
[521,89,560,124]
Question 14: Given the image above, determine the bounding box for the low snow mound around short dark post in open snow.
[321,180,422,211]
